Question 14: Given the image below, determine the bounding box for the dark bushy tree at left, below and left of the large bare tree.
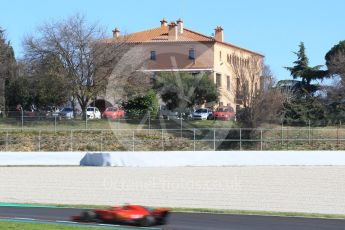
[6,55,70,109]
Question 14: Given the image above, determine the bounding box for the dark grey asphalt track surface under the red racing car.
[0,206,345,230]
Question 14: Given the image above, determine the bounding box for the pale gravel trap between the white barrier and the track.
[0,166,345,214]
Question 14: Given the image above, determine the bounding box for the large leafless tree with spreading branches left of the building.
[24,14,122,113]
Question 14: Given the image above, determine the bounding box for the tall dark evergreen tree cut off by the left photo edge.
[0,28,16,111]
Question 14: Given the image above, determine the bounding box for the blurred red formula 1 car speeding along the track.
[72,205,169,227]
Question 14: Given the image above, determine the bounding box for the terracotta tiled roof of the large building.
[103,26,263,57]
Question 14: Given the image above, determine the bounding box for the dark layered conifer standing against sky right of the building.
[285,42,327,89]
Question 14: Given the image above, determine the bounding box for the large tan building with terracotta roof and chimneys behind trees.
[106,19,264,109]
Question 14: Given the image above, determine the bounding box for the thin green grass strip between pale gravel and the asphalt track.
[0,203,345,219]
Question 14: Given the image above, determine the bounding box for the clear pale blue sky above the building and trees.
[0,0,345,80]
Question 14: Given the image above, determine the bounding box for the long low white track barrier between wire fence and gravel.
[0,151,345,167]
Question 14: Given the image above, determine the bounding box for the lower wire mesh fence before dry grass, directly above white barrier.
[0,127,345,151]
